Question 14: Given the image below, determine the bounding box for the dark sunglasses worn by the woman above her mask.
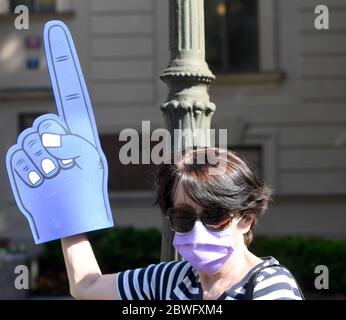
[167,207,234,233]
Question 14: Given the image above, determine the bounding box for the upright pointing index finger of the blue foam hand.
[44,21,100,147]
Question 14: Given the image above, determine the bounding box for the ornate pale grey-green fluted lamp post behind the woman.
[161,0,216,261]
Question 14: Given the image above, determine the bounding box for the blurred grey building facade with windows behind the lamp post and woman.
[0,0,346,298]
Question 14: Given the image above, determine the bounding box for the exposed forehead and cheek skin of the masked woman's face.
[173,185,248,246]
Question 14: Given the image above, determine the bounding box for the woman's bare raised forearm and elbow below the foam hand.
[61,235,119,300]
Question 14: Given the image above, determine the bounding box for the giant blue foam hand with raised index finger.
[6,21,113,243]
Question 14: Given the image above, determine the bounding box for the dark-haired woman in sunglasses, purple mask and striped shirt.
[62,148,303,300]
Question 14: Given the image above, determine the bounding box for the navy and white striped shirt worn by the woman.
[116,257,302,300]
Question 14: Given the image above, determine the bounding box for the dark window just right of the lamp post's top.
[204,0,260,73]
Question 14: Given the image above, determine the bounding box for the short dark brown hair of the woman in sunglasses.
[155,147,272,246]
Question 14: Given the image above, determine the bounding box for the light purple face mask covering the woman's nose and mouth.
[173,219,240,273]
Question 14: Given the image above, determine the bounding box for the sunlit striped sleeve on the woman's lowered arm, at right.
[253,266,303,300]
